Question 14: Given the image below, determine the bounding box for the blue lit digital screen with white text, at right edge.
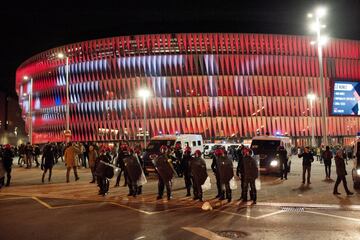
[332,81,360,116]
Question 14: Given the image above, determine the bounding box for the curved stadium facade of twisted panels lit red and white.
[16,33,360,143]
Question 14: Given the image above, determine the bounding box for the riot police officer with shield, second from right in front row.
[216,150,234,202]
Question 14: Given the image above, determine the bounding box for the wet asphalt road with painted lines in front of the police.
[0,157,360,240]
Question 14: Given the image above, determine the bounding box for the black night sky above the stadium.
[0,0,360,95]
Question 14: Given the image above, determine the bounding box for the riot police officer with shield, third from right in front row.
[190,150,208,201]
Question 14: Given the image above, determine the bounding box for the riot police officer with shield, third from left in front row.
[153,145,174,200]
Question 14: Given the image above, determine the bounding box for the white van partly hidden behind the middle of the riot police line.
[144,134,204,171]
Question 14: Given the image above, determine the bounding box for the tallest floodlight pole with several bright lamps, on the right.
[307,7,328,146]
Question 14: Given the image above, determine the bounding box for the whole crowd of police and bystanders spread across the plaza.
[0,142,360,204]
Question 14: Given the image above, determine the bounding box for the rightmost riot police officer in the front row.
[241,148,259,204]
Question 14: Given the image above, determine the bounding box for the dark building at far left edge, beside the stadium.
[0,91,28,145]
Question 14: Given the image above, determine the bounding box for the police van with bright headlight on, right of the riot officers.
[250,136,291,173]
